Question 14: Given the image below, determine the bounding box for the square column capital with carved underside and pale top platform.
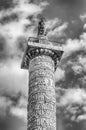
[21,37,63,69]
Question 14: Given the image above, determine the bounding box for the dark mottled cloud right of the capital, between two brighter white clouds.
[56,50,86,89]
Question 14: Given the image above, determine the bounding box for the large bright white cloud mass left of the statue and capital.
[0,0,48,92]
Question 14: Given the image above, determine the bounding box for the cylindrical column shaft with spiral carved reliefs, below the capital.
[28,55,56,130]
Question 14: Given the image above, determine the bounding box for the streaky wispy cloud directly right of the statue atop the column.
[45,18,68,40]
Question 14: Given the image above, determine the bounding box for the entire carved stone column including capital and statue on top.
[21,17,63,130]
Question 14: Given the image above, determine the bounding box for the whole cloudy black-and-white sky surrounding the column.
[0,0,86,130]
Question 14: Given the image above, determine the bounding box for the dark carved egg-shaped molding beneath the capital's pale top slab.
[21,40,63,69]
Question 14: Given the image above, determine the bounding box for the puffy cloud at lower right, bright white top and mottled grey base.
[57,88,86,122]
